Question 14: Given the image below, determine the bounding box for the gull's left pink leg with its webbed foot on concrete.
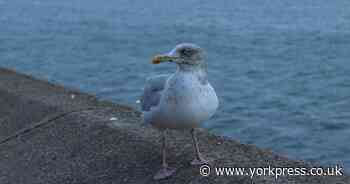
[153,130,176,180]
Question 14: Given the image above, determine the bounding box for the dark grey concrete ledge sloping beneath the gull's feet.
[0,69,350,184]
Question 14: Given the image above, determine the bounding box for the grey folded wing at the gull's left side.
[141,75,170,111]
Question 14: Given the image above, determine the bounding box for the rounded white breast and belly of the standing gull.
[156,72,218,129]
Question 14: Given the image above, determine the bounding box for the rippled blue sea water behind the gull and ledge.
[0,0,350,169]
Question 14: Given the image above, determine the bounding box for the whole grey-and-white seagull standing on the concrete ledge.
[141,43,219,180]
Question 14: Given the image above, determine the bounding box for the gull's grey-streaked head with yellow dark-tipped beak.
[152,43,205,67]
